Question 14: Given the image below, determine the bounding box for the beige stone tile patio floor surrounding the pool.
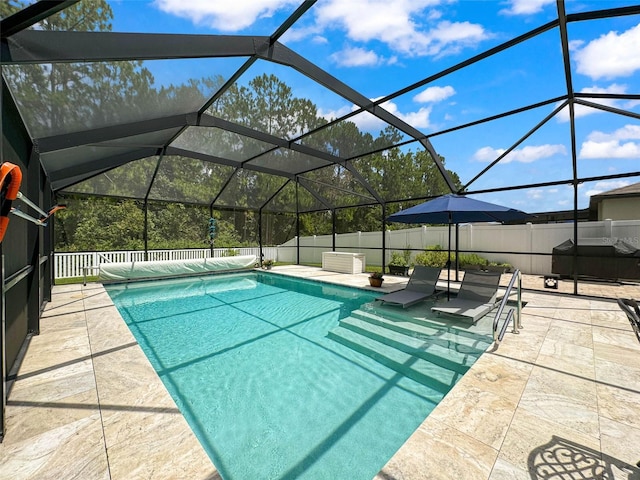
[0,266,640,480]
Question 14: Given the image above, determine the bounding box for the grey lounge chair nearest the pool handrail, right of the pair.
[431,271,500,323]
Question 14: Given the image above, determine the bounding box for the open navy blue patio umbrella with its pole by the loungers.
[387,193,530,298]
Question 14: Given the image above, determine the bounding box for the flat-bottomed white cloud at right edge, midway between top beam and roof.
[578,125,640,159]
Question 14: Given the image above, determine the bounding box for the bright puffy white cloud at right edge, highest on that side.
[574,24,640,79]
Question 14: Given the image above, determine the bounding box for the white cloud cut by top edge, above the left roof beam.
[153,0,299,32]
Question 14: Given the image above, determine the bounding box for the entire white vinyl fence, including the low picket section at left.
[55,220,640,278]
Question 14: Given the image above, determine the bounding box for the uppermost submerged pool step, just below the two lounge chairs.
[351,310,492,355]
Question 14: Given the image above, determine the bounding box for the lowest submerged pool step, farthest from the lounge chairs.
[328,326,462,394]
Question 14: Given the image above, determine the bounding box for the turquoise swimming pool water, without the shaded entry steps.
[107,272,492,480]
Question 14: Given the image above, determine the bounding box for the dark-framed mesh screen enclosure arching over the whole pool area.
[0,0,640,472]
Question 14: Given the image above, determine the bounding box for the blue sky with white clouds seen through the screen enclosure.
[110,0,640,212]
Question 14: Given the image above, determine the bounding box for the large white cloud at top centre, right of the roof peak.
[314,0,488,56]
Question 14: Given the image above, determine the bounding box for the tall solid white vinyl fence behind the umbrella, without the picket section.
[278,220,640,275]
